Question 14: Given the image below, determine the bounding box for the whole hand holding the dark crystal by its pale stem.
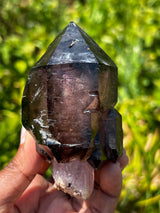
[0,129,128,213]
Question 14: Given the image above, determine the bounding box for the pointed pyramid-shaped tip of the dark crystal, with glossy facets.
[34,23,116,68]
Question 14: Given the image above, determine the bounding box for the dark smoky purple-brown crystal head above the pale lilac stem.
[22,22,123,164]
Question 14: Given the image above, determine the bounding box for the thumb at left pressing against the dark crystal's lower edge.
[0,128,49,212]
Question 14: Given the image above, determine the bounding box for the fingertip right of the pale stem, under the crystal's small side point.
[78,161,122,213]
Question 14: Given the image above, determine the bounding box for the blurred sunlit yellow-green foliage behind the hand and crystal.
[0,0,160,213]
